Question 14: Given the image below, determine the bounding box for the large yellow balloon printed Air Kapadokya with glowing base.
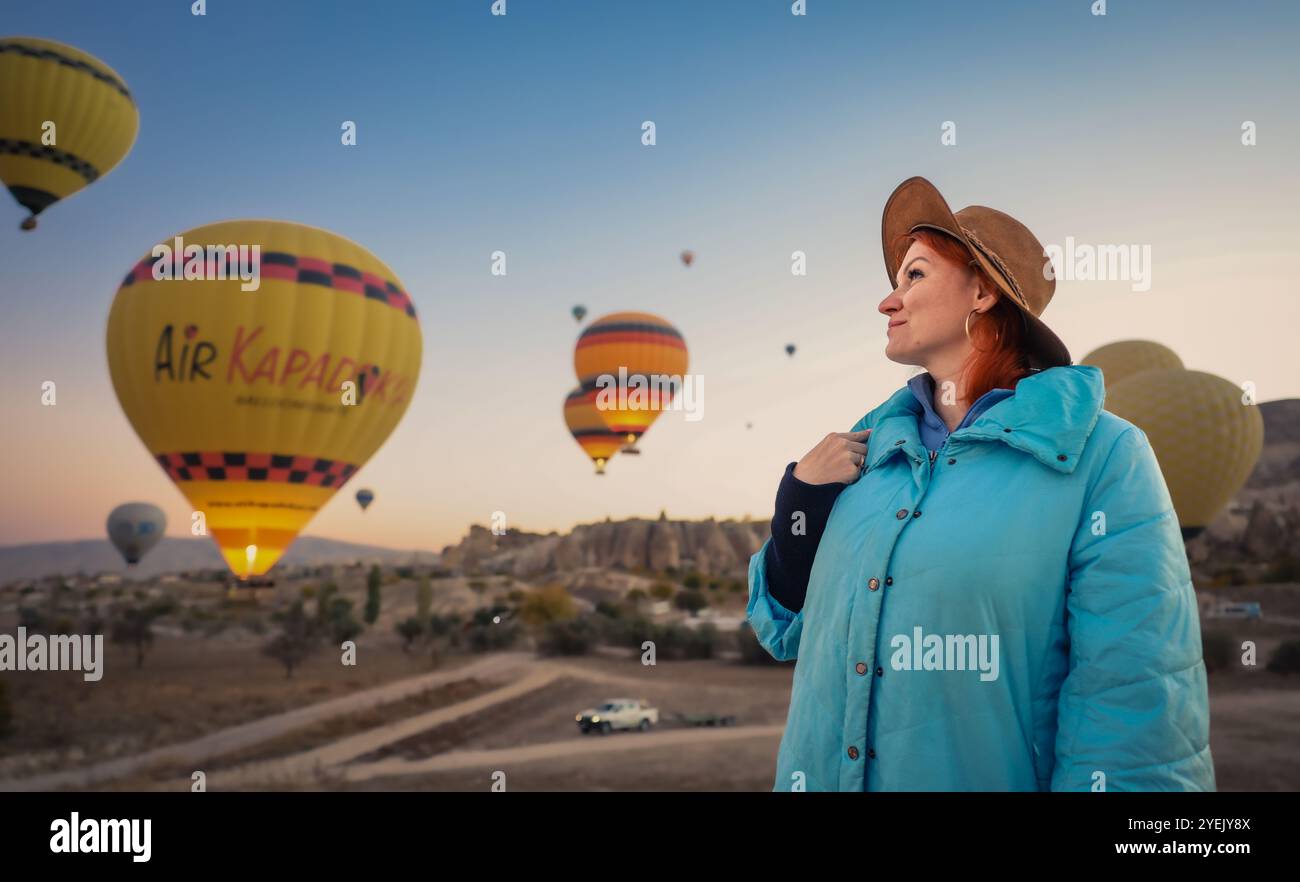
[108,220,421,578]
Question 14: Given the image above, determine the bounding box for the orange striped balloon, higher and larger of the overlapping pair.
[573,312,689,453]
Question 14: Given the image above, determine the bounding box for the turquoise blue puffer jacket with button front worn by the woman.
[748,366,1214,791]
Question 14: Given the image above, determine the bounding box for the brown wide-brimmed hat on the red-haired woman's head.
[880,177,1073,369]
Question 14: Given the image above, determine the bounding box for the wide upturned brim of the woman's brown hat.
[880,177,1074,369]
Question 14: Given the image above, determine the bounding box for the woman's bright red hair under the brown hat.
[893,229,1030,402]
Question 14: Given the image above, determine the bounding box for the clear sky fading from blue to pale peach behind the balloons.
[0,0,1300,549]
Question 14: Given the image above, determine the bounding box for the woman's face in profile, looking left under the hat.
[879,242,996,372]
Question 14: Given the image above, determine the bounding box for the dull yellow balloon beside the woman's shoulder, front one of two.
[1106,368,1264,539]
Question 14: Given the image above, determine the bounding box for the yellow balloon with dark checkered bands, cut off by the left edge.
[0,36,140,230]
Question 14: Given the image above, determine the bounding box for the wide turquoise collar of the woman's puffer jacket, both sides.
[866,364,1106,474]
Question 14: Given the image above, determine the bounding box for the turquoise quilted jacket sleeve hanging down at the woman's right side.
[1052,427,1214,791]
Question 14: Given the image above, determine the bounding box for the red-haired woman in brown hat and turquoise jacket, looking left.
[748,178,1214,791]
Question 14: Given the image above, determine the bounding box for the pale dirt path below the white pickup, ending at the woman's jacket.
[338,725,785,781]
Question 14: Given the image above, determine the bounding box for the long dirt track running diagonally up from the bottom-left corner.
[0,652,533,792]
